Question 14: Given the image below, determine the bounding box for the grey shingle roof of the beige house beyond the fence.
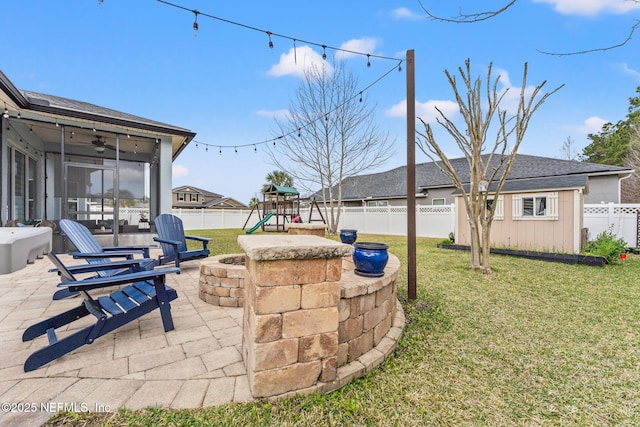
[318,154,633,200]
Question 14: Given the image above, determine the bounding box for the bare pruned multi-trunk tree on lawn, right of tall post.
[416,60,562,273]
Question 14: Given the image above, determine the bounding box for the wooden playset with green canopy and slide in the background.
[242,184,326,234]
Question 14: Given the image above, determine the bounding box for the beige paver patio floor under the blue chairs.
[0,247,253,425]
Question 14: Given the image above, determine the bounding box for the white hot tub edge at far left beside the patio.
[0,227,52,274]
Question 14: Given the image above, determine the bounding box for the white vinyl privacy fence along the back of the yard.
[120,203,640,247]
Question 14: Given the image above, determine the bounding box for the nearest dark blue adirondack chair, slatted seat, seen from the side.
[22,252,179,372]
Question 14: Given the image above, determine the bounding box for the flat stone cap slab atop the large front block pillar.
[238,234,353,261]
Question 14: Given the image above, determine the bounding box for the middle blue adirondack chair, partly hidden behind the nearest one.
[53,219,157,300]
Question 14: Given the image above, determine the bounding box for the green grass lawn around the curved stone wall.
[50,230,640,427]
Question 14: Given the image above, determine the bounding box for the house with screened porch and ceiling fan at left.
[0,71,195,244]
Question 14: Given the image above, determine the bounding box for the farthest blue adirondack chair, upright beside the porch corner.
[153,214,211,267]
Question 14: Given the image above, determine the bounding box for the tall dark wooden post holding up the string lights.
[407,49,417,300]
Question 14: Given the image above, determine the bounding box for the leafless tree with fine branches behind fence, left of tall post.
[270,62,394,233]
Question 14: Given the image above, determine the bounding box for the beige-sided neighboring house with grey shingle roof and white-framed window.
[318,154,633,253]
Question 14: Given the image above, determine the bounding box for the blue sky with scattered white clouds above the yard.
[0,0,640,203]
